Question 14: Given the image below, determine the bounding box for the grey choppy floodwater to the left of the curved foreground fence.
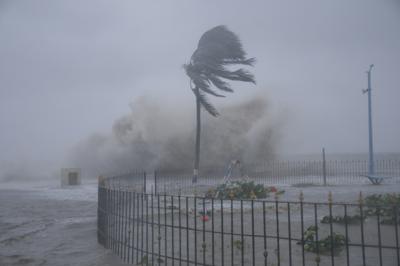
[0,181,125,266]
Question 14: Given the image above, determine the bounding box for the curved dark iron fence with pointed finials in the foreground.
[98,179,400,266]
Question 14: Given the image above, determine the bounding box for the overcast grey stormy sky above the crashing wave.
[0,0,400,179]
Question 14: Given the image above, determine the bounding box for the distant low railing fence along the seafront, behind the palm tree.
[152,160,400,194]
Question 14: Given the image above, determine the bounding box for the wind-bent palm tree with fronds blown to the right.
[184,26,255,183]
